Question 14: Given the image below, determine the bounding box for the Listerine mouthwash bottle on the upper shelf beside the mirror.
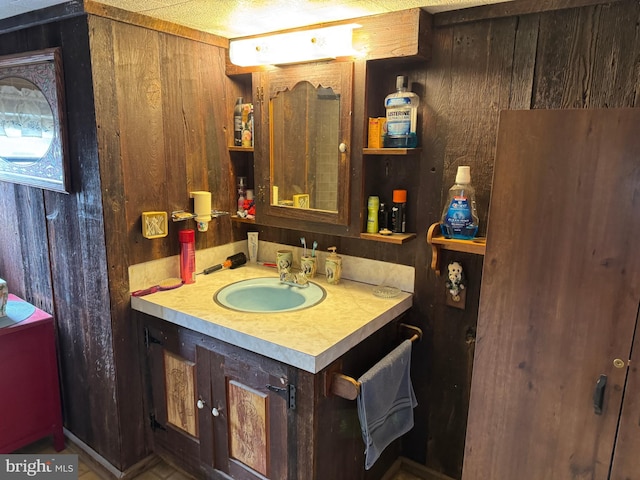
[384,75,420,148]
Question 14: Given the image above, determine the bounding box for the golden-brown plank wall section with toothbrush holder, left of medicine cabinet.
[89,16,238,466]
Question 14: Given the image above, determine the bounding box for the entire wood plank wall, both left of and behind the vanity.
[0,0,640,478]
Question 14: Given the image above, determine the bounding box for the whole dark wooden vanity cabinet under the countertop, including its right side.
[137,313,399,480]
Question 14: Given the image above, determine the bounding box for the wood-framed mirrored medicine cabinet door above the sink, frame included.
[267,62,353,225]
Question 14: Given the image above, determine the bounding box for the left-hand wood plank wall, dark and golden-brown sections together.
[0,11,239,471]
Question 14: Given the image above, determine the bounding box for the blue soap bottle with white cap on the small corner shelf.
[440,166,479,240]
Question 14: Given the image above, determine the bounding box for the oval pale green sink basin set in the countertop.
[213,277,327,313]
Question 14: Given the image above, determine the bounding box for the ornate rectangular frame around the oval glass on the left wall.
[0,48,70,193]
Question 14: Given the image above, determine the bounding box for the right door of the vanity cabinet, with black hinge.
[198,348,295,480]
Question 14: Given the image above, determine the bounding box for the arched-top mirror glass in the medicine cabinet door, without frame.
[270,81,340,213]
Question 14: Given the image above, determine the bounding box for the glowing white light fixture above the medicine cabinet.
[229,24,359,67]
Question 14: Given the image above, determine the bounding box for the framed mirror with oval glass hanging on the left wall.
[0,48,70,193]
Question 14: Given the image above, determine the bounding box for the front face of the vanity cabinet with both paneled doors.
[144,320,295,479]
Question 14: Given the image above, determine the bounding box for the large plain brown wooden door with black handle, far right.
[463,109,640,480]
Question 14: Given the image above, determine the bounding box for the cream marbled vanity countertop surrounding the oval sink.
[131,264,413,373]
